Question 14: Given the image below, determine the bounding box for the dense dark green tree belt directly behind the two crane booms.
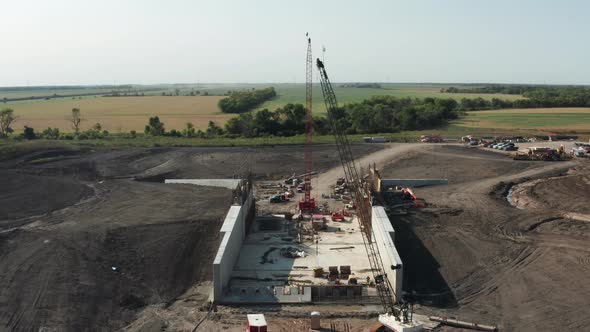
[225,96,460,137]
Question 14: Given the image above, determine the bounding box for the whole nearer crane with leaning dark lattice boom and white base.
[316,59,423,332]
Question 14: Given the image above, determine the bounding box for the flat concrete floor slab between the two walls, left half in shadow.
[230,218,371,286]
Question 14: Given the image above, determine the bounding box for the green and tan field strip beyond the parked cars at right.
[455,108,590,133]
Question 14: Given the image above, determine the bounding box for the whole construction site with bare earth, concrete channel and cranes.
[0,40,590,332]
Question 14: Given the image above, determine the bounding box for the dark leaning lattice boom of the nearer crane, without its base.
[316,59,399,318]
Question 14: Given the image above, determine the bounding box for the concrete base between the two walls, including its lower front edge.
[227,215,376,303]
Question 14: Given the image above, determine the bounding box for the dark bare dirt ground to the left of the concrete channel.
[0,146,380,331]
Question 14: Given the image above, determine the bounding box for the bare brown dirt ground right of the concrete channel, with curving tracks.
[383,146,590,331]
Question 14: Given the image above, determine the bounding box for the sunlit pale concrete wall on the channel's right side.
[371,206,403,302]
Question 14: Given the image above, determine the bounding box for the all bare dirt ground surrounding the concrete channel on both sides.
[0,144,590,332]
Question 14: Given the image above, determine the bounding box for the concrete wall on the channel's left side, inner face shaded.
[213,191,254,302]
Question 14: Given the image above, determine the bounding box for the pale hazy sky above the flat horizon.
[0,0,590,86]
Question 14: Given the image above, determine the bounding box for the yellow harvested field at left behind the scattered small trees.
[6,96,235,133]
